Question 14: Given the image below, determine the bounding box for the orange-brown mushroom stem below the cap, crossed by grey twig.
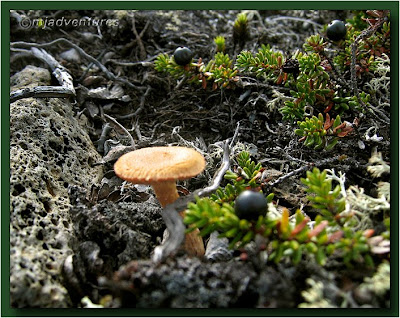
[151,181,205,256]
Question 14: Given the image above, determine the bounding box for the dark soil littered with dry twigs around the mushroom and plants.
[11,10,390,308]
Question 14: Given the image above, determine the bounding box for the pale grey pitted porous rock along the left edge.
[10,67,102,307]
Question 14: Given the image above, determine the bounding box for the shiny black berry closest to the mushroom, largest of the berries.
[235,190,267,221]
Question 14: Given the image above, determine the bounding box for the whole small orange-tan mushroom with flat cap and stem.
[114,147,205,256]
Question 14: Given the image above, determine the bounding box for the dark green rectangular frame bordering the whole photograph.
[1,1,399,317]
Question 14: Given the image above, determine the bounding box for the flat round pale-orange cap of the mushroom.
[114,147,206,184]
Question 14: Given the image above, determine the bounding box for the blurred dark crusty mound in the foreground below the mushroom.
[104,254,304,308]
